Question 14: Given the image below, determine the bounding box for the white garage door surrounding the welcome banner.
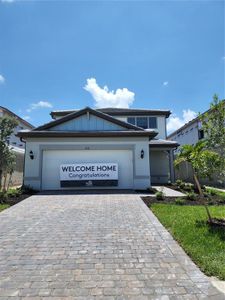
[42,150,133,190]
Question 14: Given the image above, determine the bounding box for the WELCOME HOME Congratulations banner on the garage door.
[60,163,118,186]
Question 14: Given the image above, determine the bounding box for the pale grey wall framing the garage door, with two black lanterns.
[24,137,151,190]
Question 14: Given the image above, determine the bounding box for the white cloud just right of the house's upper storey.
[167,109,197,132]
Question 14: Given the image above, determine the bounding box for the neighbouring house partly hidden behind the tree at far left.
[0,106,34,185]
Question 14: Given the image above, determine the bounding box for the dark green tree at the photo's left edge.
[0,116,18,190]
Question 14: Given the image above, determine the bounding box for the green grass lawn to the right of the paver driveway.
[151,204,225,280]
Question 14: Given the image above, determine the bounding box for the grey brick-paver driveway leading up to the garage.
[0,194,225,300]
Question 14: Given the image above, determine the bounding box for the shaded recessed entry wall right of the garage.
[149,149,170,184]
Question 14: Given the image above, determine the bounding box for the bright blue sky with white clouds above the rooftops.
[0,0,225,131]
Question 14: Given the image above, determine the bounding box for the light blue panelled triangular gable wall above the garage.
[49,113,124,131]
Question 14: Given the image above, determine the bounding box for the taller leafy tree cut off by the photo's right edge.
[200,94,225,179]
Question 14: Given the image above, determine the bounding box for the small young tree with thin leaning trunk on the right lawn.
[174,141,220,222]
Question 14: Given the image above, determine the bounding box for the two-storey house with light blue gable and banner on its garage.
[18,107,178,190]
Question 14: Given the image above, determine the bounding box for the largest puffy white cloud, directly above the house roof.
[84,78,135,108]
